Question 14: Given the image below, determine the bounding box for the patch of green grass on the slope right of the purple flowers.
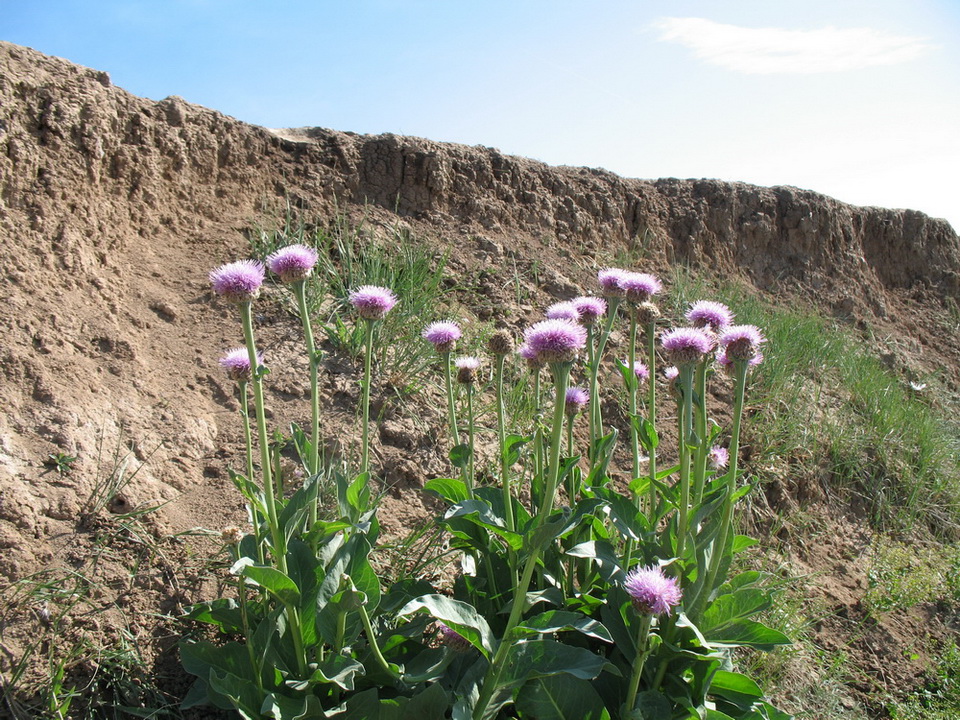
[668,271,960,537]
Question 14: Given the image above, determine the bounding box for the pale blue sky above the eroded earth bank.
[0,0,960,228]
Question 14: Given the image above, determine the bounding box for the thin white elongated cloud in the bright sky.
[654,17,932,75]
